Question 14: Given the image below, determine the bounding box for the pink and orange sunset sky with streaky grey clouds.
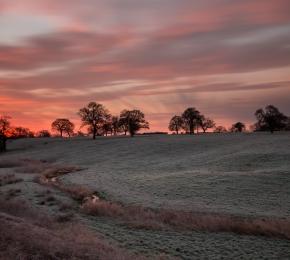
[0,0,290,131]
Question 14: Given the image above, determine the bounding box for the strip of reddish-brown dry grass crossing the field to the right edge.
[82,201,290,239]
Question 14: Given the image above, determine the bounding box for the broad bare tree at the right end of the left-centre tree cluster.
[120,110,149,137]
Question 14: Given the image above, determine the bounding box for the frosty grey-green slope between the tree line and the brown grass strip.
[5,133,290,216]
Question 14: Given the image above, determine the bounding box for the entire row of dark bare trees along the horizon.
[0,102,290,152]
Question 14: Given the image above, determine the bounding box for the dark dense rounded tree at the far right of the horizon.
[255,105,288,133]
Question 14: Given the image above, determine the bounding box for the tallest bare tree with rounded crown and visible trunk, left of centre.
[78,102,109,139]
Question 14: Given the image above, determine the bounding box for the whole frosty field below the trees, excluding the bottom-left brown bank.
[0,133,290,259]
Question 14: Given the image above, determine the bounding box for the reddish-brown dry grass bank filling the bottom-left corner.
[0,200,140,260]
